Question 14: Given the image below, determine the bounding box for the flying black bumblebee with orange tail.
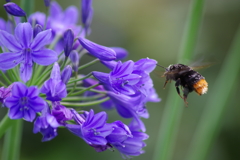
[158,64,208,106]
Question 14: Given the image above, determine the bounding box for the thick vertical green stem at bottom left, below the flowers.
[2,120,23,160]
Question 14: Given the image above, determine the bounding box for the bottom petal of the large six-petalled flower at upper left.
[19,61,32,82]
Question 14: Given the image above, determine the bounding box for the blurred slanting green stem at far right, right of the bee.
[187,26,240,160]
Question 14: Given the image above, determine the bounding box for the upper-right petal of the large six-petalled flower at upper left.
[31,29,52,51]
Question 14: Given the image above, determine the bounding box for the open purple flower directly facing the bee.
[93,58,157,96]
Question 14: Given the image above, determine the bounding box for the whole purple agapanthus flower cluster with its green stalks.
[0,0,160,158]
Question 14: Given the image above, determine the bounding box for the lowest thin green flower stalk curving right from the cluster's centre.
[61,97,110,107]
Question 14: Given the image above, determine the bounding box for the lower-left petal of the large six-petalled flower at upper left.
[0,53,22,70]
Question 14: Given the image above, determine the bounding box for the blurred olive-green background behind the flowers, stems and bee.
[0,0,240,160]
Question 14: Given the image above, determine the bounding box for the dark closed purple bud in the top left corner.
[3,2,26,17]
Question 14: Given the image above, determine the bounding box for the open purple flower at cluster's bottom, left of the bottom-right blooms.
[66,110,112,147]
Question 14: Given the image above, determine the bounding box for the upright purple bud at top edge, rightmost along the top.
[82,0,93,33]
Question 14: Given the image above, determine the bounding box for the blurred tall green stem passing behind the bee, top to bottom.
[153,0,204,160]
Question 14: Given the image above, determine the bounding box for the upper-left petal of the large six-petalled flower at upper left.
[0,30,22,52]
